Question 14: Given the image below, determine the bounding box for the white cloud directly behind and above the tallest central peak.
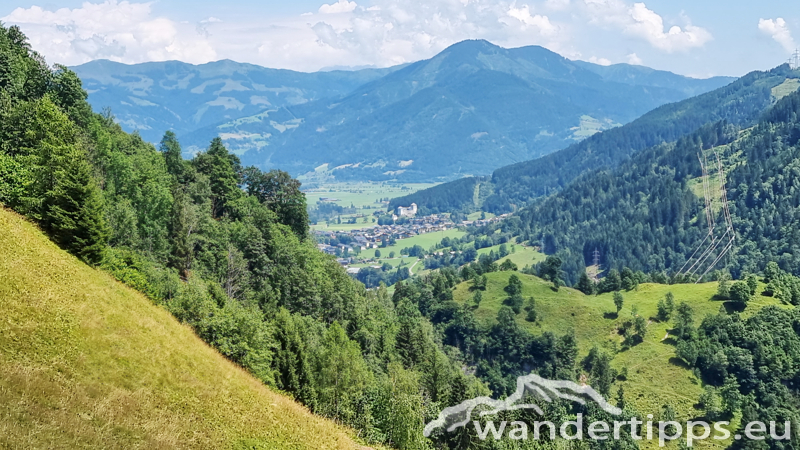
[312,0,569,66]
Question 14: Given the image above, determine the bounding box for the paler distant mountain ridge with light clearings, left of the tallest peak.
[71,60,402,150]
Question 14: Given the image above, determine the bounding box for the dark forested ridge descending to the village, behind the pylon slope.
[394,65,797,213]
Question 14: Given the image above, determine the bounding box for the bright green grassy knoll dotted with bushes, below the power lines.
[453,272,779,448]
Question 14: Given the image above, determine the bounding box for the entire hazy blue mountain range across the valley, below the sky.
[74,40,733,181]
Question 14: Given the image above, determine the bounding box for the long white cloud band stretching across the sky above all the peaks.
[0,0,711,71]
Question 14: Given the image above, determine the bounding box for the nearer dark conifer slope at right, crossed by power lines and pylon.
[506,73,800,282]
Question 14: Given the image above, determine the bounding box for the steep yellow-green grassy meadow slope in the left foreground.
[0,208,374,449]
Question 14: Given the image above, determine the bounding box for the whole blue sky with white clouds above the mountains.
[0,0,800,78]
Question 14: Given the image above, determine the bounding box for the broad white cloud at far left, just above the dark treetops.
[2,0,216,64]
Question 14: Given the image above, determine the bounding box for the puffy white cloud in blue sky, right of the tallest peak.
[584,0,712,53]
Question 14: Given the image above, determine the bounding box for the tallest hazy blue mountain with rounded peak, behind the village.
[208,41,728,180]
